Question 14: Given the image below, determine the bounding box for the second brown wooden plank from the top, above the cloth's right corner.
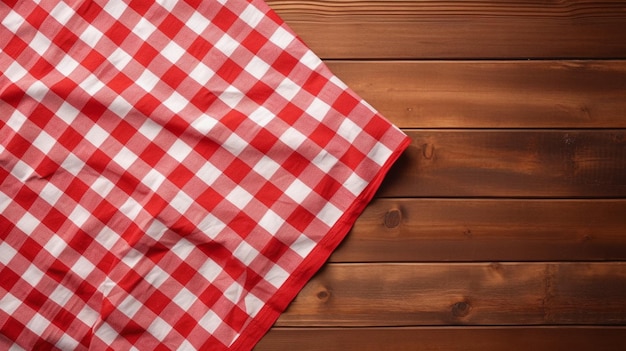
[327,60,626,128]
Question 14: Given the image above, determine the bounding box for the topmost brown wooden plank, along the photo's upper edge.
[268,0,626,59]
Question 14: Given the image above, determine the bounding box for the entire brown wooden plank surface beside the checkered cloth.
[255,0,626,351]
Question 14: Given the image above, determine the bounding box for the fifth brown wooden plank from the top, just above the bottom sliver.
[277,262,626,327]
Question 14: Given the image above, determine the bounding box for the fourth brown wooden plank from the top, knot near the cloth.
[330,199,626,262]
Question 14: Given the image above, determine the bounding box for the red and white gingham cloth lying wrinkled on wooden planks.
[0,0,409,350]
